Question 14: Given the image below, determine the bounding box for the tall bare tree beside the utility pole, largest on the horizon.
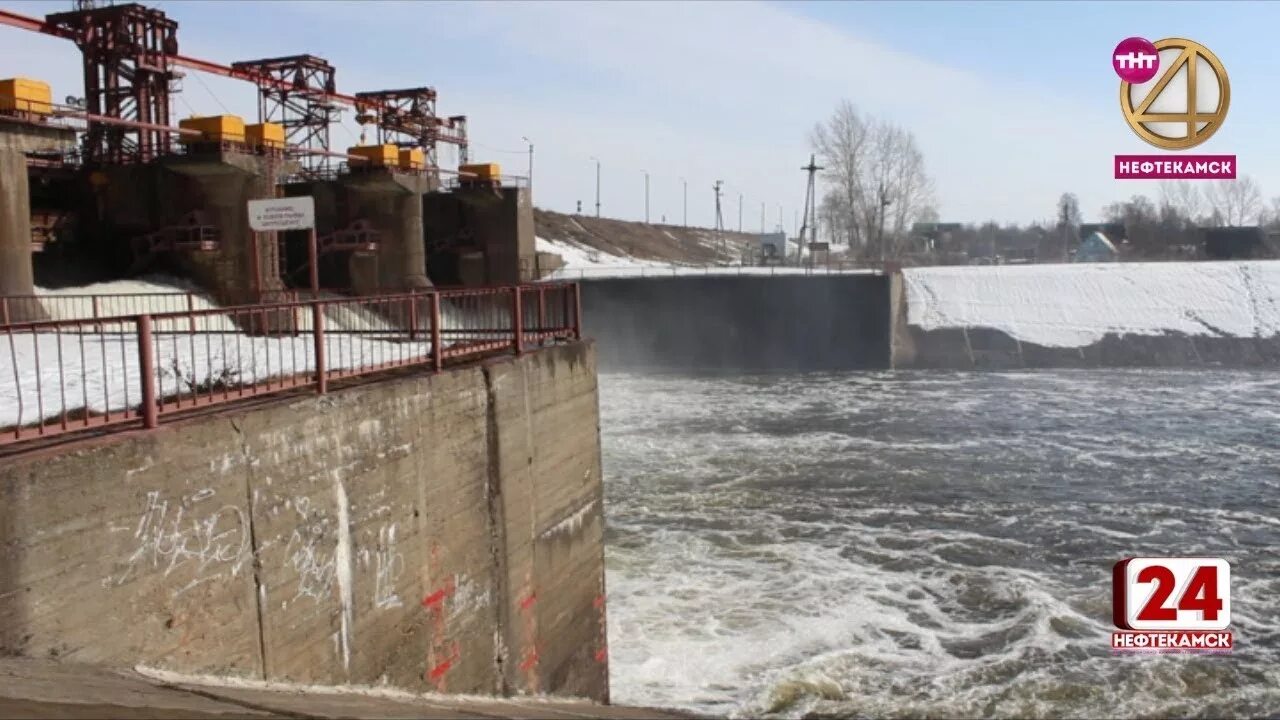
[810,100,934,252]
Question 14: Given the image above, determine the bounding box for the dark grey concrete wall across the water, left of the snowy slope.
[581,274,890,370]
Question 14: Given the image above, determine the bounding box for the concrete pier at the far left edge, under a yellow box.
[0,119,76,316]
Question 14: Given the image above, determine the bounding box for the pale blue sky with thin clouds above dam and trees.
[0,0,1280,229]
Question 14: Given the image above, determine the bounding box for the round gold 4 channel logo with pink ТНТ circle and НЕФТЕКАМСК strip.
[1111,37,1236,179]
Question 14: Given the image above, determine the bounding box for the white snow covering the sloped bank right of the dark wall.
[904,261,1280,347]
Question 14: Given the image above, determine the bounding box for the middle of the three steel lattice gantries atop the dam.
[232,55,340,177]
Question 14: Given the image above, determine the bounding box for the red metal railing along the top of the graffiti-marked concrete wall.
[0,283,581,446]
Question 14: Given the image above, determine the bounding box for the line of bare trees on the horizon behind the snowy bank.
[809,100,1280,263]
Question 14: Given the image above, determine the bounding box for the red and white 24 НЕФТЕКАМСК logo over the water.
[1111,557,1233,653]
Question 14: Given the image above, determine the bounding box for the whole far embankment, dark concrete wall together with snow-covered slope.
[581,261,1280,372]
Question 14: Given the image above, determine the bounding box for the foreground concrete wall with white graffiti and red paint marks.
[0,343,608,701]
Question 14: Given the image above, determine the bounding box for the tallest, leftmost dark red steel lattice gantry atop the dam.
[45,3,178,164]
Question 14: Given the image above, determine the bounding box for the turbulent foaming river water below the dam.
[600,370,1280,717]
